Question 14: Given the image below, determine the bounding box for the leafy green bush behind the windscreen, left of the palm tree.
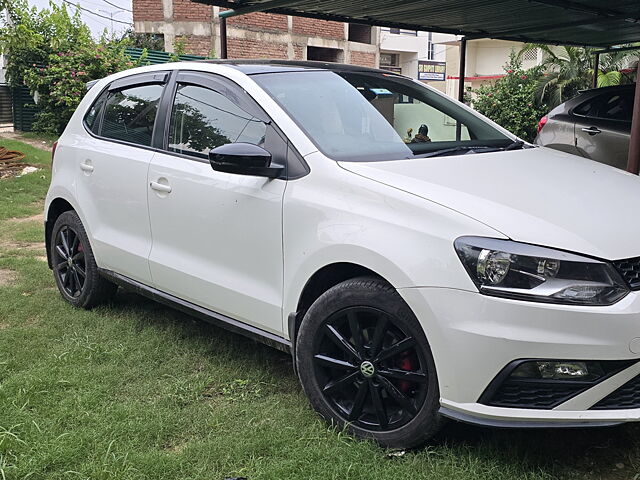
[473,53,548,141]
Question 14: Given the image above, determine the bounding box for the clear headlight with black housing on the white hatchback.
[454,237,629,305]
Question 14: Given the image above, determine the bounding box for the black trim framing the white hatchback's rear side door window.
[82,70,171,151]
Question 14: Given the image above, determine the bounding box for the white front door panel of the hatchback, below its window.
[146,153,286,333]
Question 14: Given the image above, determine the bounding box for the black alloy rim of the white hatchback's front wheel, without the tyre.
[314,306,428,431]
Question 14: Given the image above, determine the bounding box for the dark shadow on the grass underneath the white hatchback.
[101,290,640,480]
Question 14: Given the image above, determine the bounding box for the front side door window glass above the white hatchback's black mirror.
[169,84,266,158]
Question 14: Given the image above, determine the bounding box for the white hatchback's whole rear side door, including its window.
[75,72,167,284]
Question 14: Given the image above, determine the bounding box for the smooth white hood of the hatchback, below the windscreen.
[339,148,640,260]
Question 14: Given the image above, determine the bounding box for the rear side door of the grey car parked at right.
[574,90,633,169]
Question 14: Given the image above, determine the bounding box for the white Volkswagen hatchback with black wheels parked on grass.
[45,61,640,447]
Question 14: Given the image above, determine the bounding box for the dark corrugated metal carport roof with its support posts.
[195,0,640,174]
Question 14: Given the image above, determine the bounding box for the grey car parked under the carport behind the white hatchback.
[535,85,635,169]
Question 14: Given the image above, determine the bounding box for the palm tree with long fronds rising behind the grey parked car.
[518,43,640,108]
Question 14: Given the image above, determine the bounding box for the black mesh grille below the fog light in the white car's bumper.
[481,380,591,409]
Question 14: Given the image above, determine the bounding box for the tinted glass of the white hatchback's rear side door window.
[101,85,163,146]
